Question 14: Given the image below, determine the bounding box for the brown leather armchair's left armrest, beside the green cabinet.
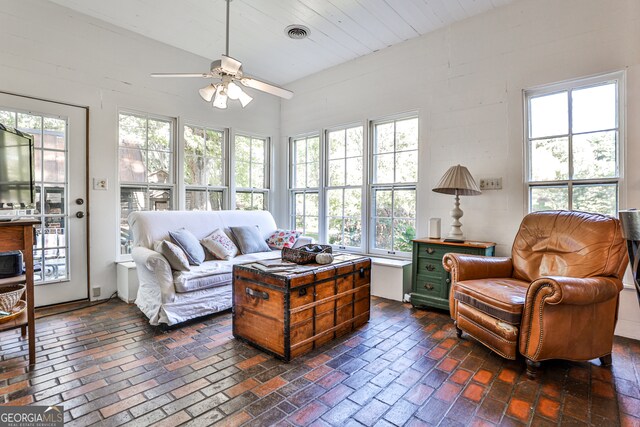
[442,253,513,283]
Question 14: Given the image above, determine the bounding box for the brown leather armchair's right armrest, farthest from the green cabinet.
[527,276,623,305]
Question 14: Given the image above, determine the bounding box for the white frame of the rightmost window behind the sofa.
[229,131,273,210]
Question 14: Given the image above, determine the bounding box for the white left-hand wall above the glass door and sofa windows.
[0,0,280,298]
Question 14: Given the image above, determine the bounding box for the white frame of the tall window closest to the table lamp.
[367,111,420,258]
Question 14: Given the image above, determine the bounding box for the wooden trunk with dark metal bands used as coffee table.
[233,257,371,361]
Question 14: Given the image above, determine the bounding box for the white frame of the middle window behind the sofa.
[178,121,231,210]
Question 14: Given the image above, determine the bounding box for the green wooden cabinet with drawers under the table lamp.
[411,238,496,310]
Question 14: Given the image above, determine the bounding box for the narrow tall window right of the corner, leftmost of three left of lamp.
[290,135,320,240]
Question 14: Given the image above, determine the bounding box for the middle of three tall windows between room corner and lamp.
[325,126,364,249]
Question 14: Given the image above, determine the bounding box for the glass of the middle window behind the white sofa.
[183,125,227,211]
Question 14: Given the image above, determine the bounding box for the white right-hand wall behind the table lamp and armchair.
[280,0,640,338]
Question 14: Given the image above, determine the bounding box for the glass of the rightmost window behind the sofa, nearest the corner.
[234,135,270,210]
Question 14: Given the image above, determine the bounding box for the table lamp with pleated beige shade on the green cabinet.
[433,165,482,243]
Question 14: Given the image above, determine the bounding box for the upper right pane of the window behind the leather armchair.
[571,83,618,133]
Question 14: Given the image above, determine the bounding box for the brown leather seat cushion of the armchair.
[452,278,529,325]
